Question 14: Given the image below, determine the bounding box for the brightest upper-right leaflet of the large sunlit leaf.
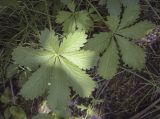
[59,31,87,53]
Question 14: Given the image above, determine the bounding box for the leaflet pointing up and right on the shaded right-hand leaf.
[119,4,140,29]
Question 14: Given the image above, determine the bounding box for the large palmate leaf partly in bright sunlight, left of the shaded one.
[13,30,97,117]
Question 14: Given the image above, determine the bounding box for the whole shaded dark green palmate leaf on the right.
[85,5,154,79]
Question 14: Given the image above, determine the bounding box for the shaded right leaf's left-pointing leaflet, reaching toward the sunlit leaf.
[84,32,111,53]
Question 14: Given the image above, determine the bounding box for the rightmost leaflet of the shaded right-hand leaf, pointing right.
[118,21,154,39]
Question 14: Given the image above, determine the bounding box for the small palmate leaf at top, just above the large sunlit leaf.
[56,10,93,33]
